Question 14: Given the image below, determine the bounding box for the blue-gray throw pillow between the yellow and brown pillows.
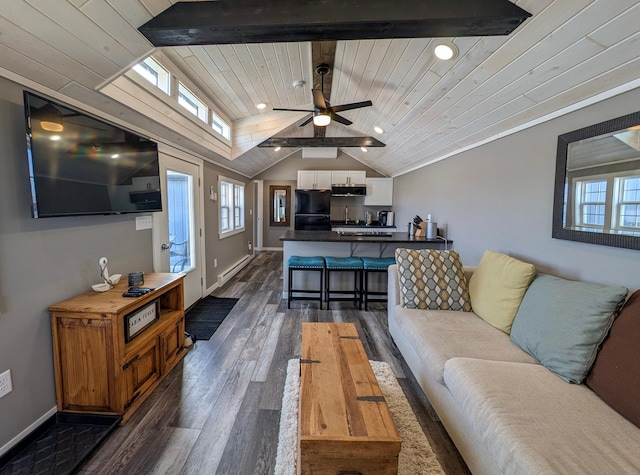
[511,275,627,383]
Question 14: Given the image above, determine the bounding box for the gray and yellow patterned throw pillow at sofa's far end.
[396,249,471,312]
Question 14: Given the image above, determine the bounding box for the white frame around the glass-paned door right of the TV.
[151,143,207,308]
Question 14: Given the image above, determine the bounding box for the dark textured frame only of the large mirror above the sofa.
[551,112,640,250]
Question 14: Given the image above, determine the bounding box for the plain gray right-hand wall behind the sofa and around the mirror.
[394,90,640,290]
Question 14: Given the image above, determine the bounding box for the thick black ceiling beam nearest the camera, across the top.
[139,0,531,46]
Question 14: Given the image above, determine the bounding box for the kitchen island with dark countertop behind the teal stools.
[280,228,452,298]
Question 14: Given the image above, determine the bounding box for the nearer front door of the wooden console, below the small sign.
[122,338,160,411]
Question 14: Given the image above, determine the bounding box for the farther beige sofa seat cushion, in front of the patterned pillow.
[393,306,537,384]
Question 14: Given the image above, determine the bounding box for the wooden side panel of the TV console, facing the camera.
[52,317,116,412]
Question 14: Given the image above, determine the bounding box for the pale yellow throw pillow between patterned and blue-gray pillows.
[469,250,536,334]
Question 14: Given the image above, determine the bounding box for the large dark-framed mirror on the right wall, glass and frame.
[552,112,640,249]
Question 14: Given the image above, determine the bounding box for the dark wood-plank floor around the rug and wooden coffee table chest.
[80,252,469,475]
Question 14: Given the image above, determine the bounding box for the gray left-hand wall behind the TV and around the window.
[0,79,253,455]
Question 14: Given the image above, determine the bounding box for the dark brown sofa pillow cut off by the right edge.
[586,290,640,427]
